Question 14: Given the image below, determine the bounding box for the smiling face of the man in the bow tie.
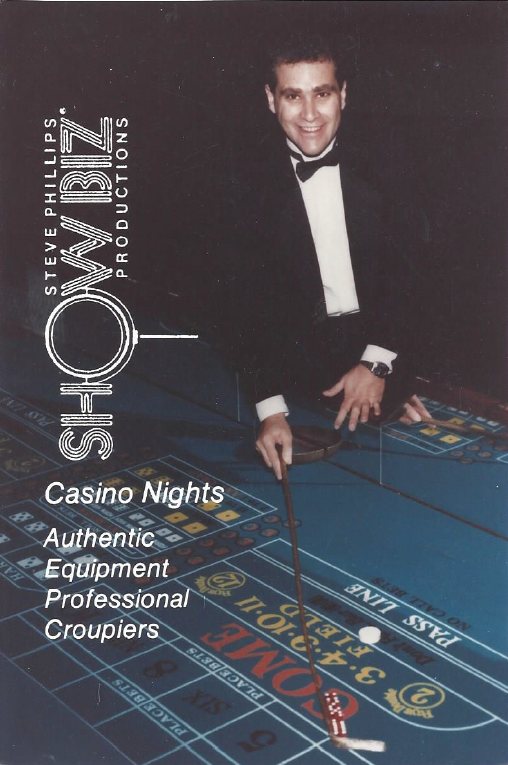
[265,61,346,157]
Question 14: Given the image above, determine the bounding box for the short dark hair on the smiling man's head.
[265,32,345,91]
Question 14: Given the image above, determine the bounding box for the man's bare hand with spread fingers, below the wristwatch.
[323,364,385,430]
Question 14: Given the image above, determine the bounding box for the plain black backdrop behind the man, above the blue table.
[0,2,508,399]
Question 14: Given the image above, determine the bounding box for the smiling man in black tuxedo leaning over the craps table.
[234,38,428,478]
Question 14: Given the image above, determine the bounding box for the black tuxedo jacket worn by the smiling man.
[211,134,411,401]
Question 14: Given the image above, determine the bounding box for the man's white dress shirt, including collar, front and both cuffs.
[256,138,397,421]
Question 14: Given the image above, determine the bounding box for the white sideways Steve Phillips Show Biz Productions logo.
[44,113,198,461]
